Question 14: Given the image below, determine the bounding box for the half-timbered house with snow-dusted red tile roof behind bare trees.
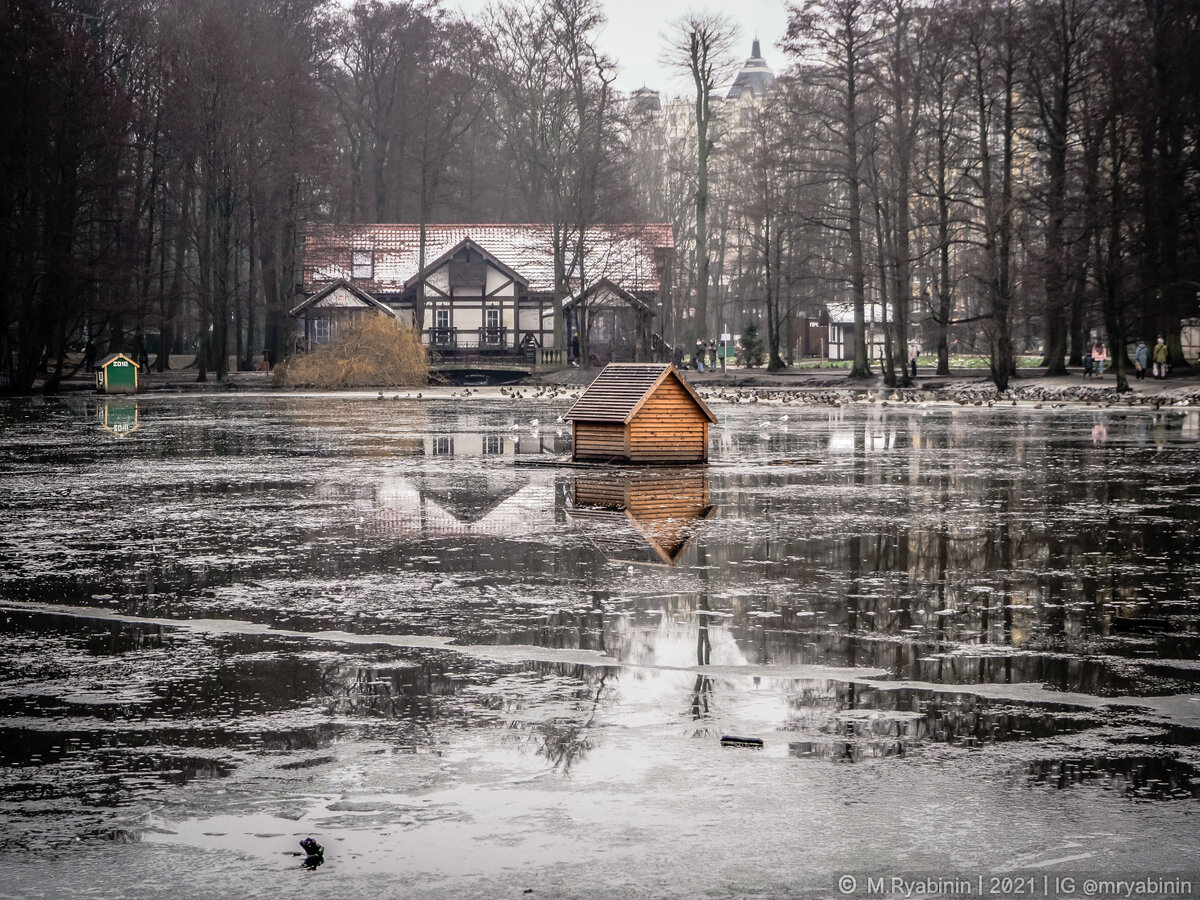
[293,223,674,361]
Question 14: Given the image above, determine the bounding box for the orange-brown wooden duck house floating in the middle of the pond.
[563,362,716,464]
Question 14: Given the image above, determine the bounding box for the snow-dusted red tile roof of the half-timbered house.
[304,223,674,293]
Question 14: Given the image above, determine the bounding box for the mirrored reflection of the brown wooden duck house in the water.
[570,473,716,565]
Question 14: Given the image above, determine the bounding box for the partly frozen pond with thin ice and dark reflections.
[0,389,1200,898]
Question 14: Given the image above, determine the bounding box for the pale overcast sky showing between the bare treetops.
[446,0,787,95]
